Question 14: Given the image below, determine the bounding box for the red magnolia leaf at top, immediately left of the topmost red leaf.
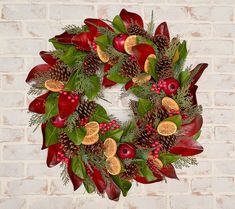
[84,18,113,36]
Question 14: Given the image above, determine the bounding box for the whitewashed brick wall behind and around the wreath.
[0,0,235,209]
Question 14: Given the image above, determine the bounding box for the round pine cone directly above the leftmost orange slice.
[50,63,71,82]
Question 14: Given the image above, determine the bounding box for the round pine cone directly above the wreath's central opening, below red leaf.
[120,59,141,78]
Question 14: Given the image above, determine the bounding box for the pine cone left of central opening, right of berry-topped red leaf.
[77,101,97,119]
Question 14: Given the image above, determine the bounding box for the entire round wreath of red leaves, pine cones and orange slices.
[26,9,207,200]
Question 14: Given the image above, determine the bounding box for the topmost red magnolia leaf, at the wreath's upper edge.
[120,9,144,28]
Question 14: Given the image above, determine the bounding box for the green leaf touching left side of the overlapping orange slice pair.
[64,127,86,145]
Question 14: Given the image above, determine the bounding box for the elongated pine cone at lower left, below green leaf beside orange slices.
[59,132,79,158]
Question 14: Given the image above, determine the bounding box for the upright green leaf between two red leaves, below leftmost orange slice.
[45,93,59,118]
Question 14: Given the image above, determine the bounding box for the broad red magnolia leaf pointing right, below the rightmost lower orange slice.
[170,136,203,156]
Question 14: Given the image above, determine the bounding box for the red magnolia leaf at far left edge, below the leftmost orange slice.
[29,92,50,114]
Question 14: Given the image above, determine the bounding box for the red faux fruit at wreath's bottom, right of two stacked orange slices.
[117,143,136,159]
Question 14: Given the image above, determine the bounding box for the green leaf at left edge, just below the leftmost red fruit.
[45,121,60,147]
